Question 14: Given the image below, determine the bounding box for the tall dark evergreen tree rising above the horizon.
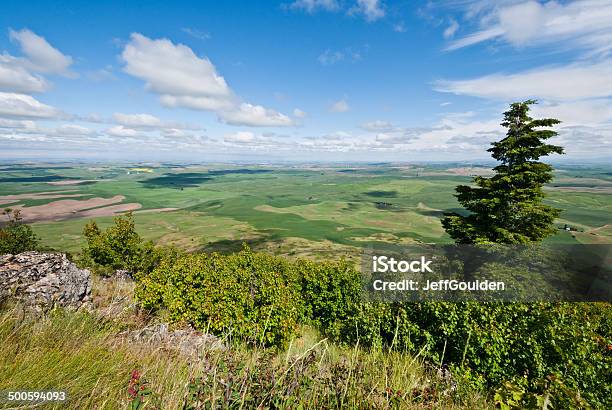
[442,100,563,244]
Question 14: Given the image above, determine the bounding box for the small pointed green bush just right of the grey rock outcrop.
[83,212,167,273]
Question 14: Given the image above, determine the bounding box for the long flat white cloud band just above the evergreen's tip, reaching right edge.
[434,60,612,101]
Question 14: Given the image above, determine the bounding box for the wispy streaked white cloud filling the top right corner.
[447,0,612,55]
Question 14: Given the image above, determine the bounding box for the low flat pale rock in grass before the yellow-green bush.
[121,323,227,358]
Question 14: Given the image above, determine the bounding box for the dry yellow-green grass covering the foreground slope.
[0,278,492,409]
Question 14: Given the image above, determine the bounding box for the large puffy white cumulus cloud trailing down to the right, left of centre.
[121,33,293,126]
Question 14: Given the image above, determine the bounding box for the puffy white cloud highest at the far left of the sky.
[9,29,75,77]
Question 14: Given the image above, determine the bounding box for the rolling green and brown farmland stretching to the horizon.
[0,164,612,258]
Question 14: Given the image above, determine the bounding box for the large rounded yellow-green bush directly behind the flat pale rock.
[136,247,302,346]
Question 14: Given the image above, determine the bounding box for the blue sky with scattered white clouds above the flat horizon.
[0,0,612,161]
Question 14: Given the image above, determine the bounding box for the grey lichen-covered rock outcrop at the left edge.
[0,252,91,311]
